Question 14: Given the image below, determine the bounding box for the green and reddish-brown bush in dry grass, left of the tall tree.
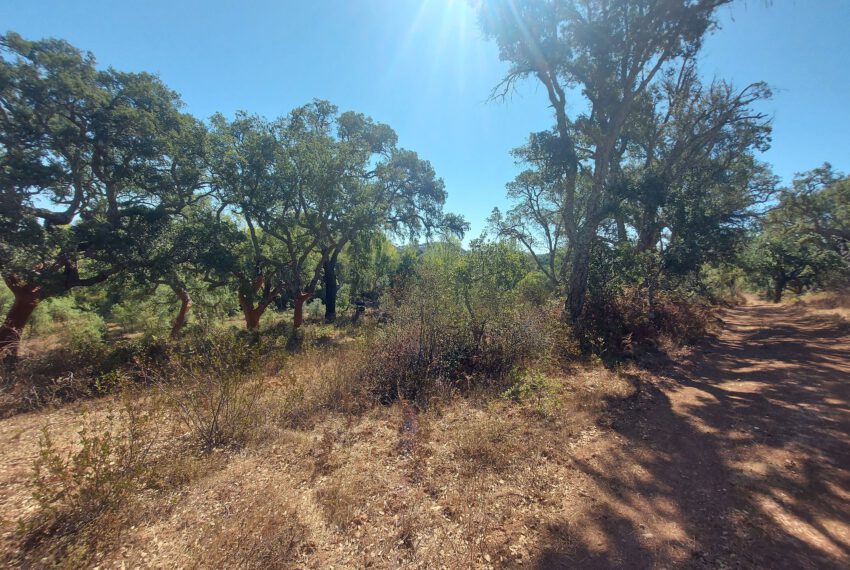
[348,240,575,402]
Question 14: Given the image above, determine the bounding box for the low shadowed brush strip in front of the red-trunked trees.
[0,316,356,418]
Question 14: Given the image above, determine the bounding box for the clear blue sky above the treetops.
[0,0,850,235]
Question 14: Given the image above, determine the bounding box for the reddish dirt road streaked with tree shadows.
[536,302,850,569]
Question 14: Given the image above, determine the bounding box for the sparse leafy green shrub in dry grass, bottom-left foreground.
[16,394,161,568]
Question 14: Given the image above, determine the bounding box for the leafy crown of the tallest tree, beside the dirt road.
[478,0,770,323]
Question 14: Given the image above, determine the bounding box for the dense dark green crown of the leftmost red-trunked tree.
[0,33,199,298]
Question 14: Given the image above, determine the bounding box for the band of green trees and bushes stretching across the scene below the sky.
[0,21,850,378]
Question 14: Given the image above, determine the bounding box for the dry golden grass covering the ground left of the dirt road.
[0,326,631,568]
